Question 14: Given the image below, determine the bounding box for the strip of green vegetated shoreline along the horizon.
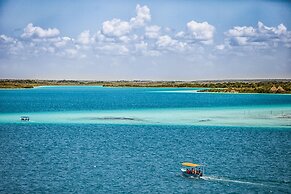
[0,79,291,93]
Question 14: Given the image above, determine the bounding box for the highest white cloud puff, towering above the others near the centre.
[130,4,151,27]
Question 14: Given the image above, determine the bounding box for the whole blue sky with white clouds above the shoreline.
[0,0,291,80]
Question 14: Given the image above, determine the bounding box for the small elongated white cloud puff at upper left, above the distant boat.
[21,23,60,38]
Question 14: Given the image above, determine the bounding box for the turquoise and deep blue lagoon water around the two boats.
[0,86,291,193]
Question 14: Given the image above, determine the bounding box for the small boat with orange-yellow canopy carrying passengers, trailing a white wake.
[181,162,204,178]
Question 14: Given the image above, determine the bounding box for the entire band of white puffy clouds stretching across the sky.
[8,5,291,61]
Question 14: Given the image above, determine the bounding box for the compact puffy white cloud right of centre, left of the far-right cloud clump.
[187,20,215,41]
